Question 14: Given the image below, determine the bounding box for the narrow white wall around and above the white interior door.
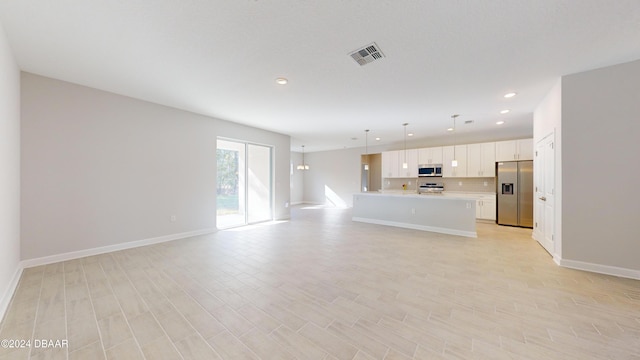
[533,79,562,259]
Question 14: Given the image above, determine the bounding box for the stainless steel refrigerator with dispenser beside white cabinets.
[497,161,533,228]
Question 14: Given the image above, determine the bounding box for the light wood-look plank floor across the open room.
[0,207,640,360]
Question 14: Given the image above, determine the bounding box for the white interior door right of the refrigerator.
[533,133,555,255]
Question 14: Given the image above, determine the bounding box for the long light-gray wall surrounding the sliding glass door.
[22,73,290,259]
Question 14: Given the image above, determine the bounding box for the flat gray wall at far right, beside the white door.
[562,60,640,270]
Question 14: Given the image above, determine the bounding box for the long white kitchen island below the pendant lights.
[352,192,478,237]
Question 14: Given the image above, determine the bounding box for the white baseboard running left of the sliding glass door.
[20,228,217,269]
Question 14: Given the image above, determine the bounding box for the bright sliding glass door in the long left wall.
[216,139,273,229]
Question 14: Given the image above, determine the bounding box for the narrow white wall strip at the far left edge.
[0,24,20,319]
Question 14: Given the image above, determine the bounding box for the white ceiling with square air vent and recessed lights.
[0,0,640,151]
